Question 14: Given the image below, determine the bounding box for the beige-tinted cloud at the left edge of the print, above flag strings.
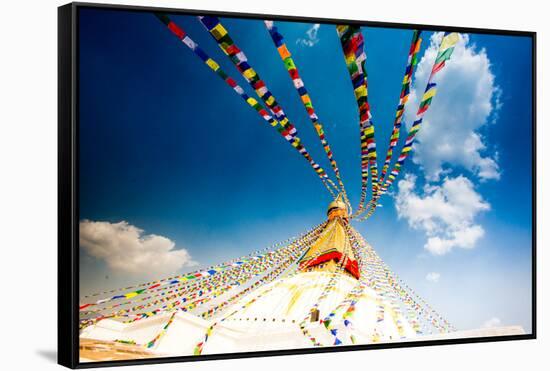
[80,220,196,278]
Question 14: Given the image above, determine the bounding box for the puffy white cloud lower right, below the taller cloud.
[395,174,490,255]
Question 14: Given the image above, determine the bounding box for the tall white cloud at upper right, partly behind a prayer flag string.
[405,33,502,181]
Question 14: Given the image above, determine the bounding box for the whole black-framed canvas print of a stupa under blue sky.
[58,3,536,368]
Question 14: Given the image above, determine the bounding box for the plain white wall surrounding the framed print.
[0,0,550,371]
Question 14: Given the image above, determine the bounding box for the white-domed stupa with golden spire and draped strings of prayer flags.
[80,197,522,360]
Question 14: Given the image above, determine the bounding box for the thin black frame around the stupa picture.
[57,2,537,368]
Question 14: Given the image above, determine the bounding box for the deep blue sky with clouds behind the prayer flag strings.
[79,9,532,331]
